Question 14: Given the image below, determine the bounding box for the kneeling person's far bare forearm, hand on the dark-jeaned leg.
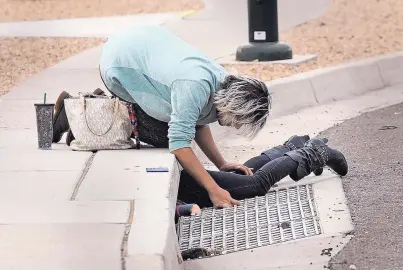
[195,126,253,175]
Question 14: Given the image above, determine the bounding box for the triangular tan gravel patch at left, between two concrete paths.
[0,38,103,96]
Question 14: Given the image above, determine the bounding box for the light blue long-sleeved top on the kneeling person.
[100,26,228,151]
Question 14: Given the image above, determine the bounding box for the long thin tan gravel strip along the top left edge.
[0,0,203,22]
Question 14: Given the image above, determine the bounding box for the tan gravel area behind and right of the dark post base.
[225,0,403,80]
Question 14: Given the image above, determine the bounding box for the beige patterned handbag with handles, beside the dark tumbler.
[64,93,135,151]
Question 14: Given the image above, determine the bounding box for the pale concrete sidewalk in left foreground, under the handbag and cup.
[0,60,180,270]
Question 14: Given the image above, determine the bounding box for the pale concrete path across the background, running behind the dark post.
[0,0,330,59]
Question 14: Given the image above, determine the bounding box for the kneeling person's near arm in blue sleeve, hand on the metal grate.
[168,81,239,207]
